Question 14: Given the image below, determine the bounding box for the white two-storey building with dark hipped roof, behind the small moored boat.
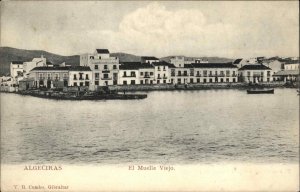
[238,64,273,83]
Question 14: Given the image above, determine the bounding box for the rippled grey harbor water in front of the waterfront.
[1,89,299,164]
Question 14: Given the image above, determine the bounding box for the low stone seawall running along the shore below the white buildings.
[109,82,284,91]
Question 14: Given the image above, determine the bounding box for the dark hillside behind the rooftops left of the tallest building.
[0,47,79,75]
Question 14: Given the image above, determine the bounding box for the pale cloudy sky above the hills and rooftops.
[1,1,299,58]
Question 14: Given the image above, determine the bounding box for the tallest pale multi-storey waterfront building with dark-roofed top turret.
[80,49,120,89]
